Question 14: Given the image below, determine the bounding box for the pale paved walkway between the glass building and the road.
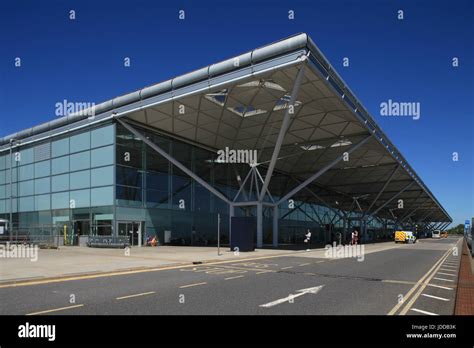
[0,242,410,283]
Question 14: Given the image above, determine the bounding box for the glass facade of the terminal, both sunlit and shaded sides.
[0,119,387,245]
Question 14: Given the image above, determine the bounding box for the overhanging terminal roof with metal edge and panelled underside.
[0,34,452,222]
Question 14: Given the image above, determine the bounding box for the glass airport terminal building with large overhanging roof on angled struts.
[0,34,452,247]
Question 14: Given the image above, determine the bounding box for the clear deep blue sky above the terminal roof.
[0,0,474,223]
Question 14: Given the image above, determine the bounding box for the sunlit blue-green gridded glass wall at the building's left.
[0,124,115,238]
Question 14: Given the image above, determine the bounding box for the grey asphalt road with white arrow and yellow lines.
[0,237,460,315]
